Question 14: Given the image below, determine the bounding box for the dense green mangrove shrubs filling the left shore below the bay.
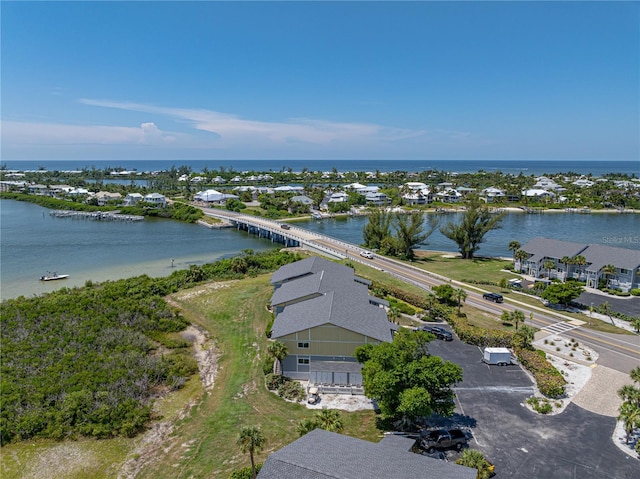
[0,250,299,444]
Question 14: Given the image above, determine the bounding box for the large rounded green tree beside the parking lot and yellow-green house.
[356,329,462,419]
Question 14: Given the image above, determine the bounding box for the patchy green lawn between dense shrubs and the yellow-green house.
[140,276,379,478]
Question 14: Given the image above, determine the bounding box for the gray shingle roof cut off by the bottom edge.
[258,429,476,479]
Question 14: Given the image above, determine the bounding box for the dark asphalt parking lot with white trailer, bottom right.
[422,335,640,479]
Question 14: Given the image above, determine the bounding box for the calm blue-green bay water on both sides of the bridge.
[0,200,640,299]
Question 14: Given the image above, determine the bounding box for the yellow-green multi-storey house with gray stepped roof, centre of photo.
[271,257,396,384]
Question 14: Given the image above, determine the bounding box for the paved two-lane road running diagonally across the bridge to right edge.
[203,208,640,373]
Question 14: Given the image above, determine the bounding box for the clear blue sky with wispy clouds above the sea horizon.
[0,1,640,160]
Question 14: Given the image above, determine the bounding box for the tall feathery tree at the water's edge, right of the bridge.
[440,196,504,259]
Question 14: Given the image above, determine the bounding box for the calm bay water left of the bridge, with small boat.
[0,200,273,299]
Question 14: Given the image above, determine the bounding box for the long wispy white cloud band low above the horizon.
[1,99,478,158]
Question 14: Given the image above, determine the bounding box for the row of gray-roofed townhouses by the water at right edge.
[514,238,640,292]
